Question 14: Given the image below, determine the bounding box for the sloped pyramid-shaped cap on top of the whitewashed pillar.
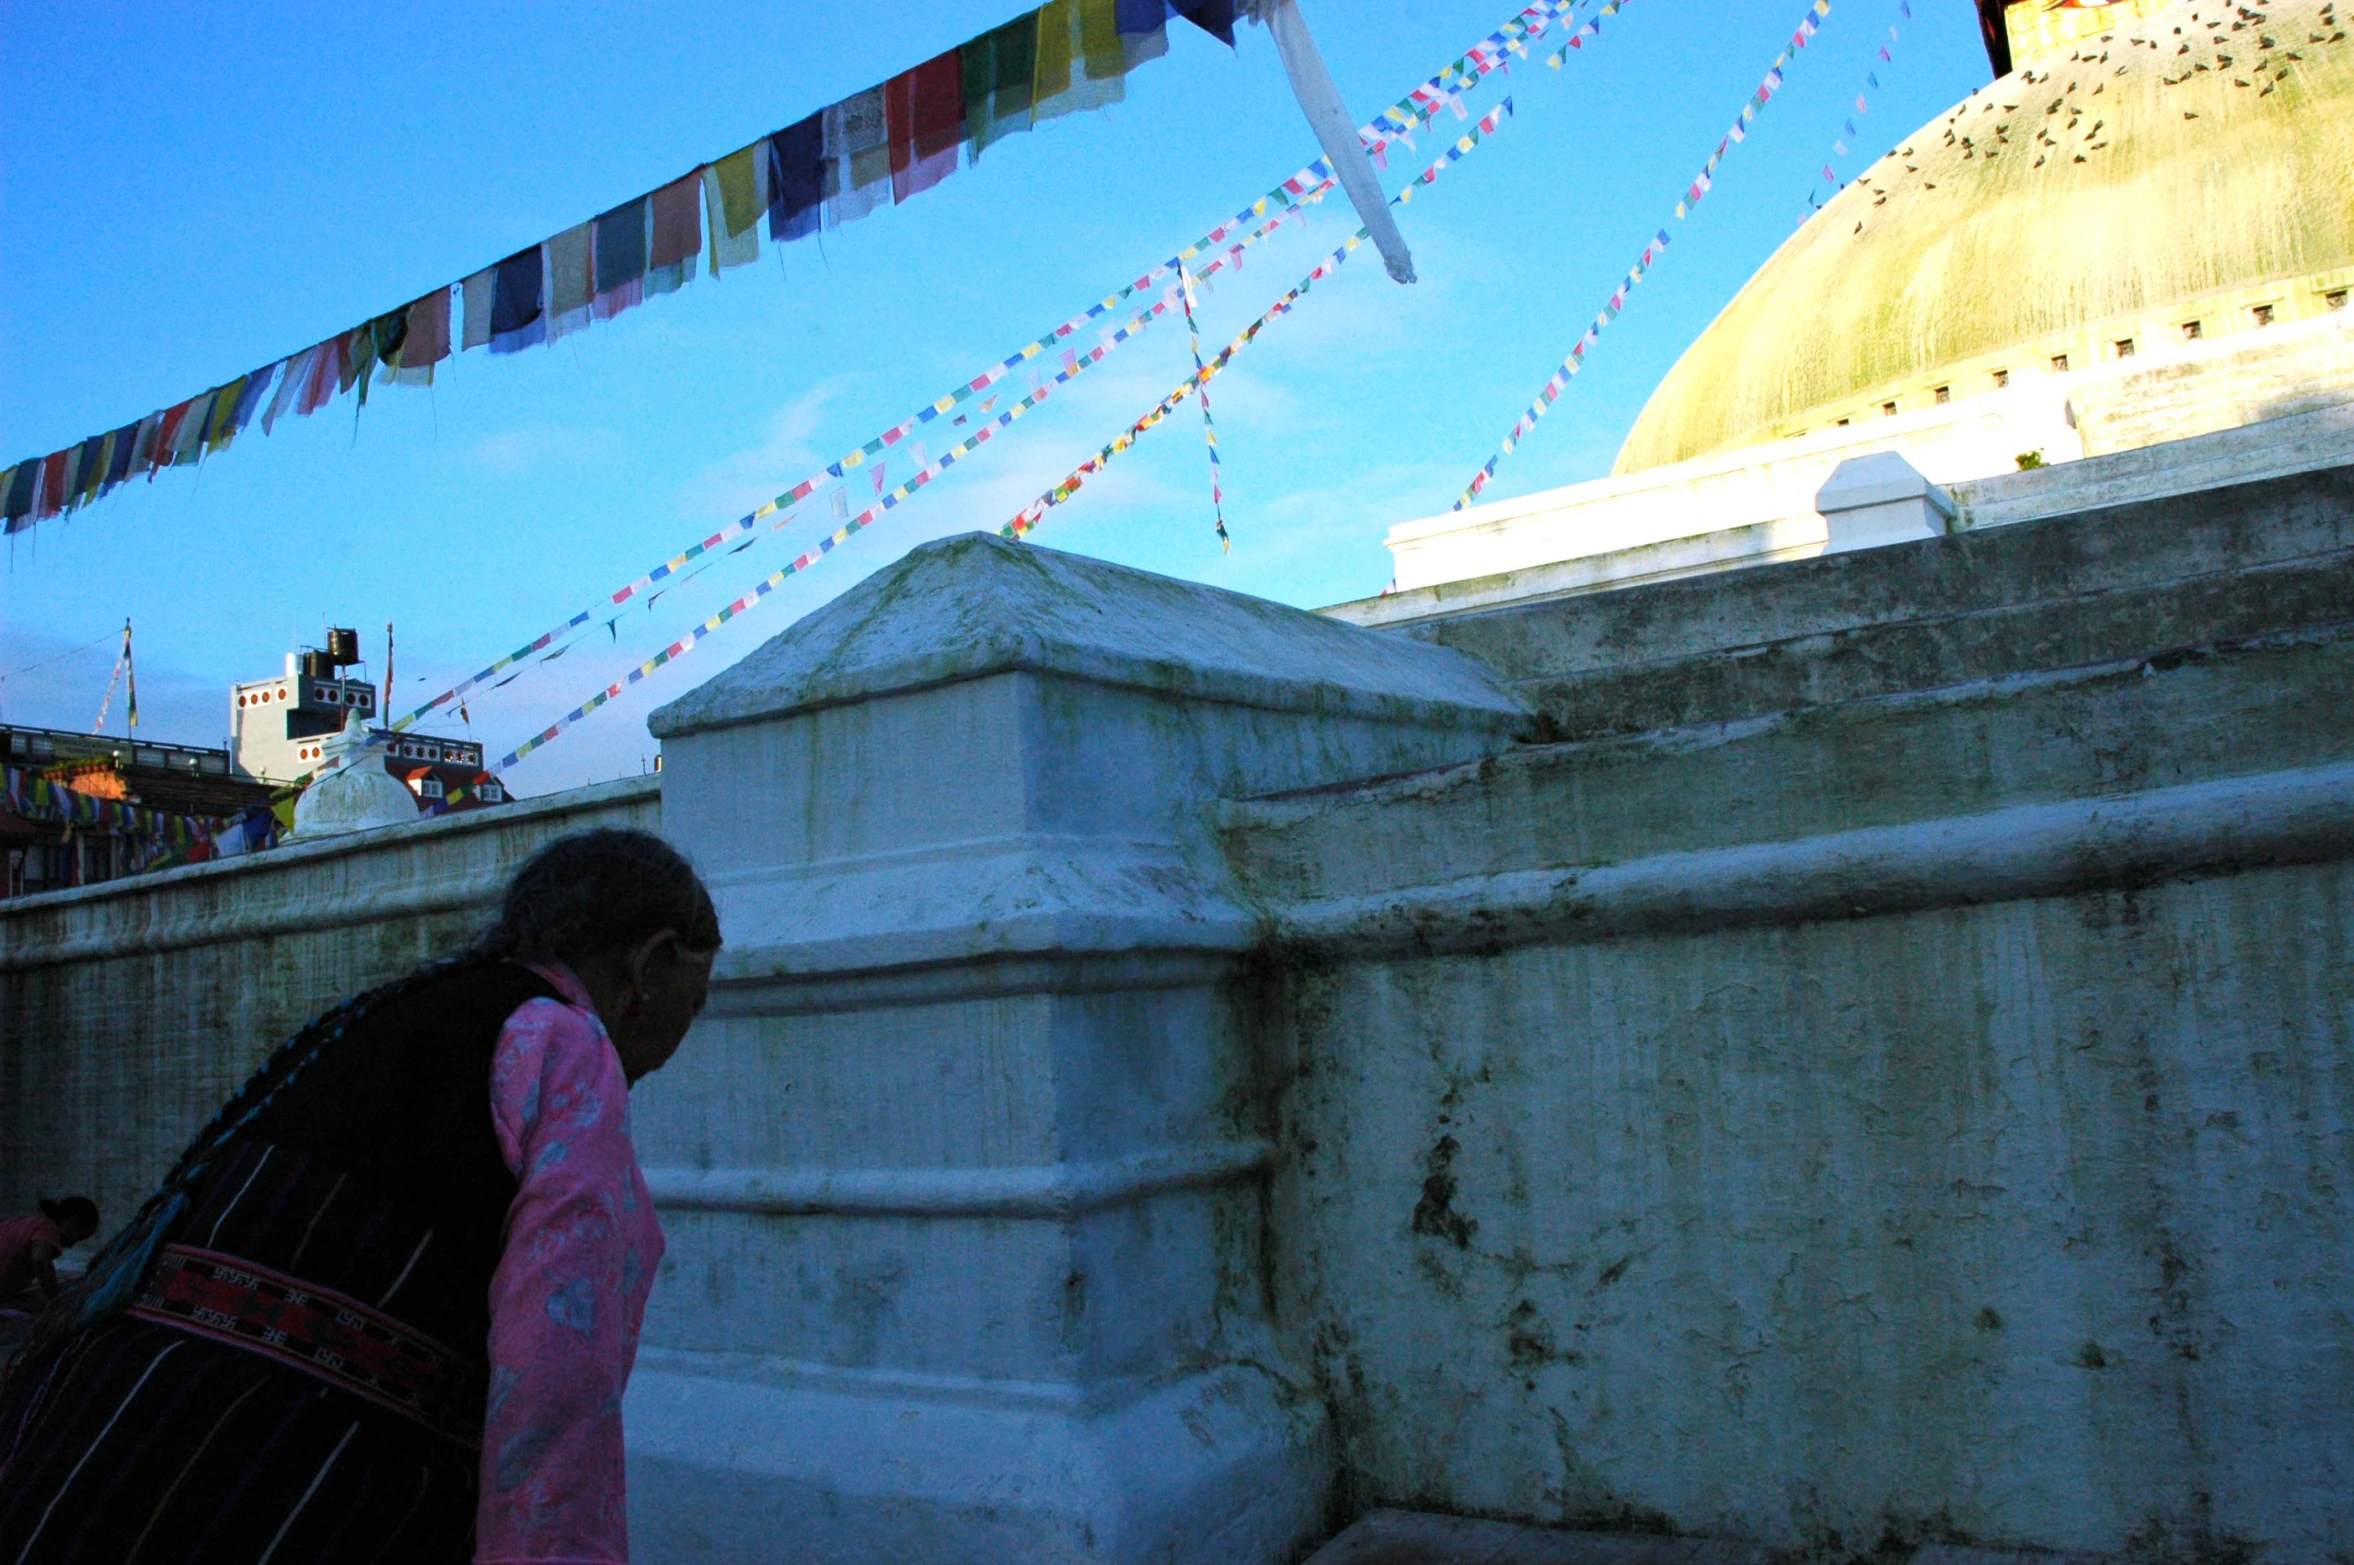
[647,532,1525,739]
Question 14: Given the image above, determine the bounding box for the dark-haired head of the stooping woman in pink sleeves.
[483,828,720,1080]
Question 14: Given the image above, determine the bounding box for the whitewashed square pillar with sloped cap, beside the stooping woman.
[629,534,1525,1565]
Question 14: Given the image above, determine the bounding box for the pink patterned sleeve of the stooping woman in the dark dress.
[473,963,661,1565]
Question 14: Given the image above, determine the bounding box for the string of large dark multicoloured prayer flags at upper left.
[0,0,1568,534]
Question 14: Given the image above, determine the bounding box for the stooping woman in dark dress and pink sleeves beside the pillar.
[0,831,720,1565]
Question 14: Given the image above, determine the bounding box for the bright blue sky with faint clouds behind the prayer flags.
[0,0,1989,793]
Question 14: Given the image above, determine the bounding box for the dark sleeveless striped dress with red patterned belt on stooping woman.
[0,958,556,1565]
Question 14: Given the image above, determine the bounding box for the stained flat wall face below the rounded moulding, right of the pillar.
[1276,864,2354,1558]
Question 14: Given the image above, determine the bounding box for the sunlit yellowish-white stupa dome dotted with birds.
[1615,0,2354,473]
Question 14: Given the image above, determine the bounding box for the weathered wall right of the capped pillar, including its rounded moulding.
[1226,548,2354,1560]
